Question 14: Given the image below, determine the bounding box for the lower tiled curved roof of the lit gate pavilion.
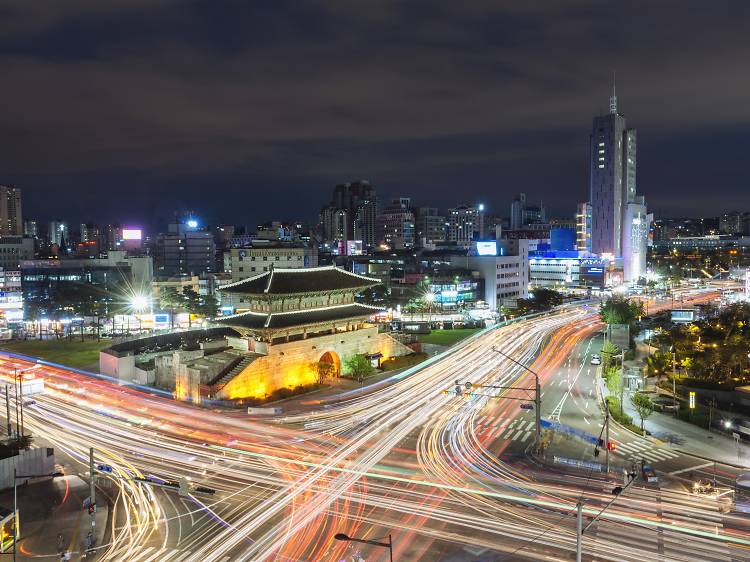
[216,303,383,330]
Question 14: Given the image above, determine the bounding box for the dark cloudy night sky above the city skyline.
[0,0,750,228]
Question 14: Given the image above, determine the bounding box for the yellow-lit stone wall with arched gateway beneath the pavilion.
[217,326,412,399]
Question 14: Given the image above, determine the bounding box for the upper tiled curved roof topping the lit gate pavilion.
[219,266,380,295]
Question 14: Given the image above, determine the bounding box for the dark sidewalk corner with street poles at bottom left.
[0,475,108,561]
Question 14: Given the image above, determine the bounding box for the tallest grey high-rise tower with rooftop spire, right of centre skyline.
[589,84,651,281]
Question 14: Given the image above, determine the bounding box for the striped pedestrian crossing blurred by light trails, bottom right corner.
[590,488,733,562]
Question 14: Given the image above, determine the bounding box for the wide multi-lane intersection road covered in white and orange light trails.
[0,290,750,562]
